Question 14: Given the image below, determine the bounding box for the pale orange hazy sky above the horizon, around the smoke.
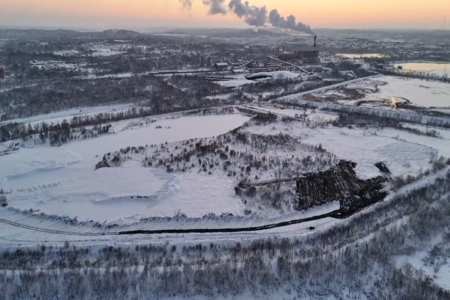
[0,0,450,29]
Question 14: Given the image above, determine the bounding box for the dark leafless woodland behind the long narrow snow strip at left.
[0,75,224,120]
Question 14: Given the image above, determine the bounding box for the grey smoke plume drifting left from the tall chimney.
[180,0,313,34]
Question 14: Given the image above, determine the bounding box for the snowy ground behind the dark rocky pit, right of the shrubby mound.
[247,122,444,178]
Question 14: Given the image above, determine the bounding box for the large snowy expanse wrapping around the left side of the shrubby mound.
[0,114,249,223]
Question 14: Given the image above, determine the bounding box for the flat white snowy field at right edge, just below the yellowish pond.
[360,76,450,108]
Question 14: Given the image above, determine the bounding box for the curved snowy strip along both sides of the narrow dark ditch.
[0,202,342,249]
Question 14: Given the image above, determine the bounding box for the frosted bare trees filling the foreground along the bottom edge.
[0,172,450,299]
